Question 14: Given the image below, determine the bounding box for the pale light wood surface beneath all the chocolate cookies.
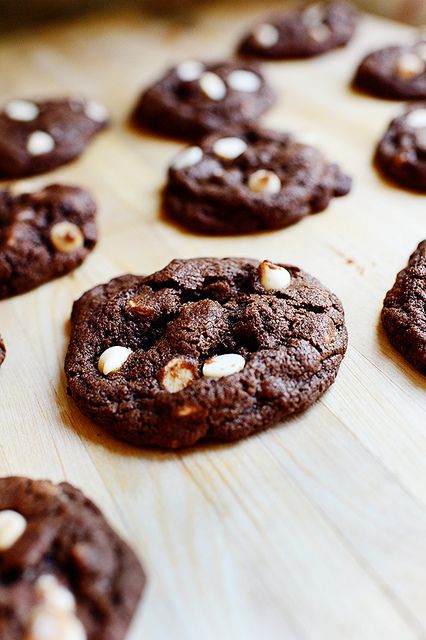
[0,3,426,640]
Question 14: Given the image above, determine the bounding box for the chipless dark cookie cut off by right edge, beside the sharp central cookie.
[382,240,426,374]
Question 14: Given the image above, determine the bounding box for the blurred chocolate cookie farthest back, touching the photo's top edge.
[239,0,358,59]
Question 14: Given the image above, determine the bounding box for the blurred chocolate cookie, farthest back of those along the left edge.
[0,98,108,179]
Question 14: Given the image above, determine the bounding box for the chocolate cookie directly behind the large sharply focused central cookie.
[163,128,351,234]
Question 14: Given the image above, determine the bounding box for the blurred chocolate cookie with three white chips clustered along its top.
[133,60,275,140]
